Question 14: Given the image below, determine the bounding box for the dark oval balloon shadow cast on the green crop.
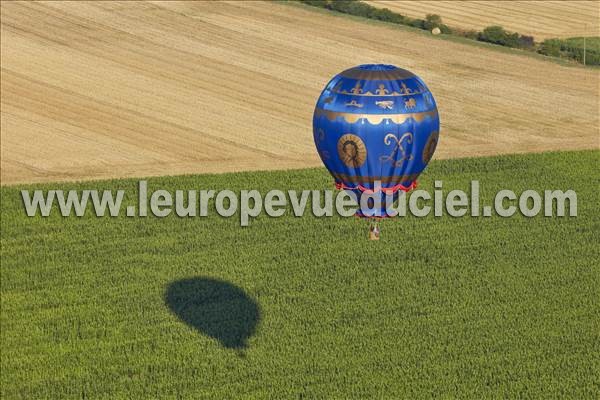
[165,277,260,350]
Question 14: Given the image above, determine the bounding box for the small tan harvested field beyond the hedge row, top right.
[368,0,600,40]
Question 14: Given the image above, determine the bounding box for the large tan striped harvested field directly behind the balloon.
[1,2,600,184]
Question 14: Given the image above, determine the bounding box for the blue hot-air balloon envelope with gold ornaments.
[313,64,440,217]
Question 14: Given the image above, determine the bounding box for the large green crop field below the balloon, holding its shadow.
[0,151,600,399]
